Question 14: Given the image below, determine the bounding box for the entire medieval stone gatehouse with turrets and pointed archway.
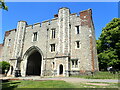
[0,8,98,76]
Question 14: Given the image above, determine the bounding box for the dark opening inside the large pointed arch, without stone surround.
[26,51,42,76]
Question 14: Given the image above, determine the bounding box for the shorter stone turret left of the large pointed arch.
[12,21,26,75]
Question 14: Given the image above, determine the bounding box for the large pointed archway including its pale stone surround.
[21,46,43,76]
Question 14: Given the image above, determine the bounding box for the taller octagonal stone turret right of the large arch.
[57,8,70,55]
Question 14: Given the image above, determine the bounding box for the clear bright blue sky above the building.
[0,2,118,43]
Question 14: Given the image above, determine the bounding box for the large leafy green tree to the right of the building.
[97,18,120,70]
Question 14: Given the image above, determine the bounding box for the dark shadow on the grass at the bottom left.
[0,80,20,90]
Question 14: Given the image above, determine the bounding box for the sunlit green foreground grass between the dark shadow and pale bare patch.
[17,81,74,88]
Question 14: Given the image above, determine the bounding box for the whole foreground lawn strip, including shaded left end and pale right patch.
[3,80,118,88]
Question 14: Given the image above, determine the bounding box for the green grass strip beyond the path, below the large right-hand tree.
[71,72,119,79]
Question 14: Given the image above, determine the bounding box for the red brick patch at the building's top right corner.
[80,9,92,28]
